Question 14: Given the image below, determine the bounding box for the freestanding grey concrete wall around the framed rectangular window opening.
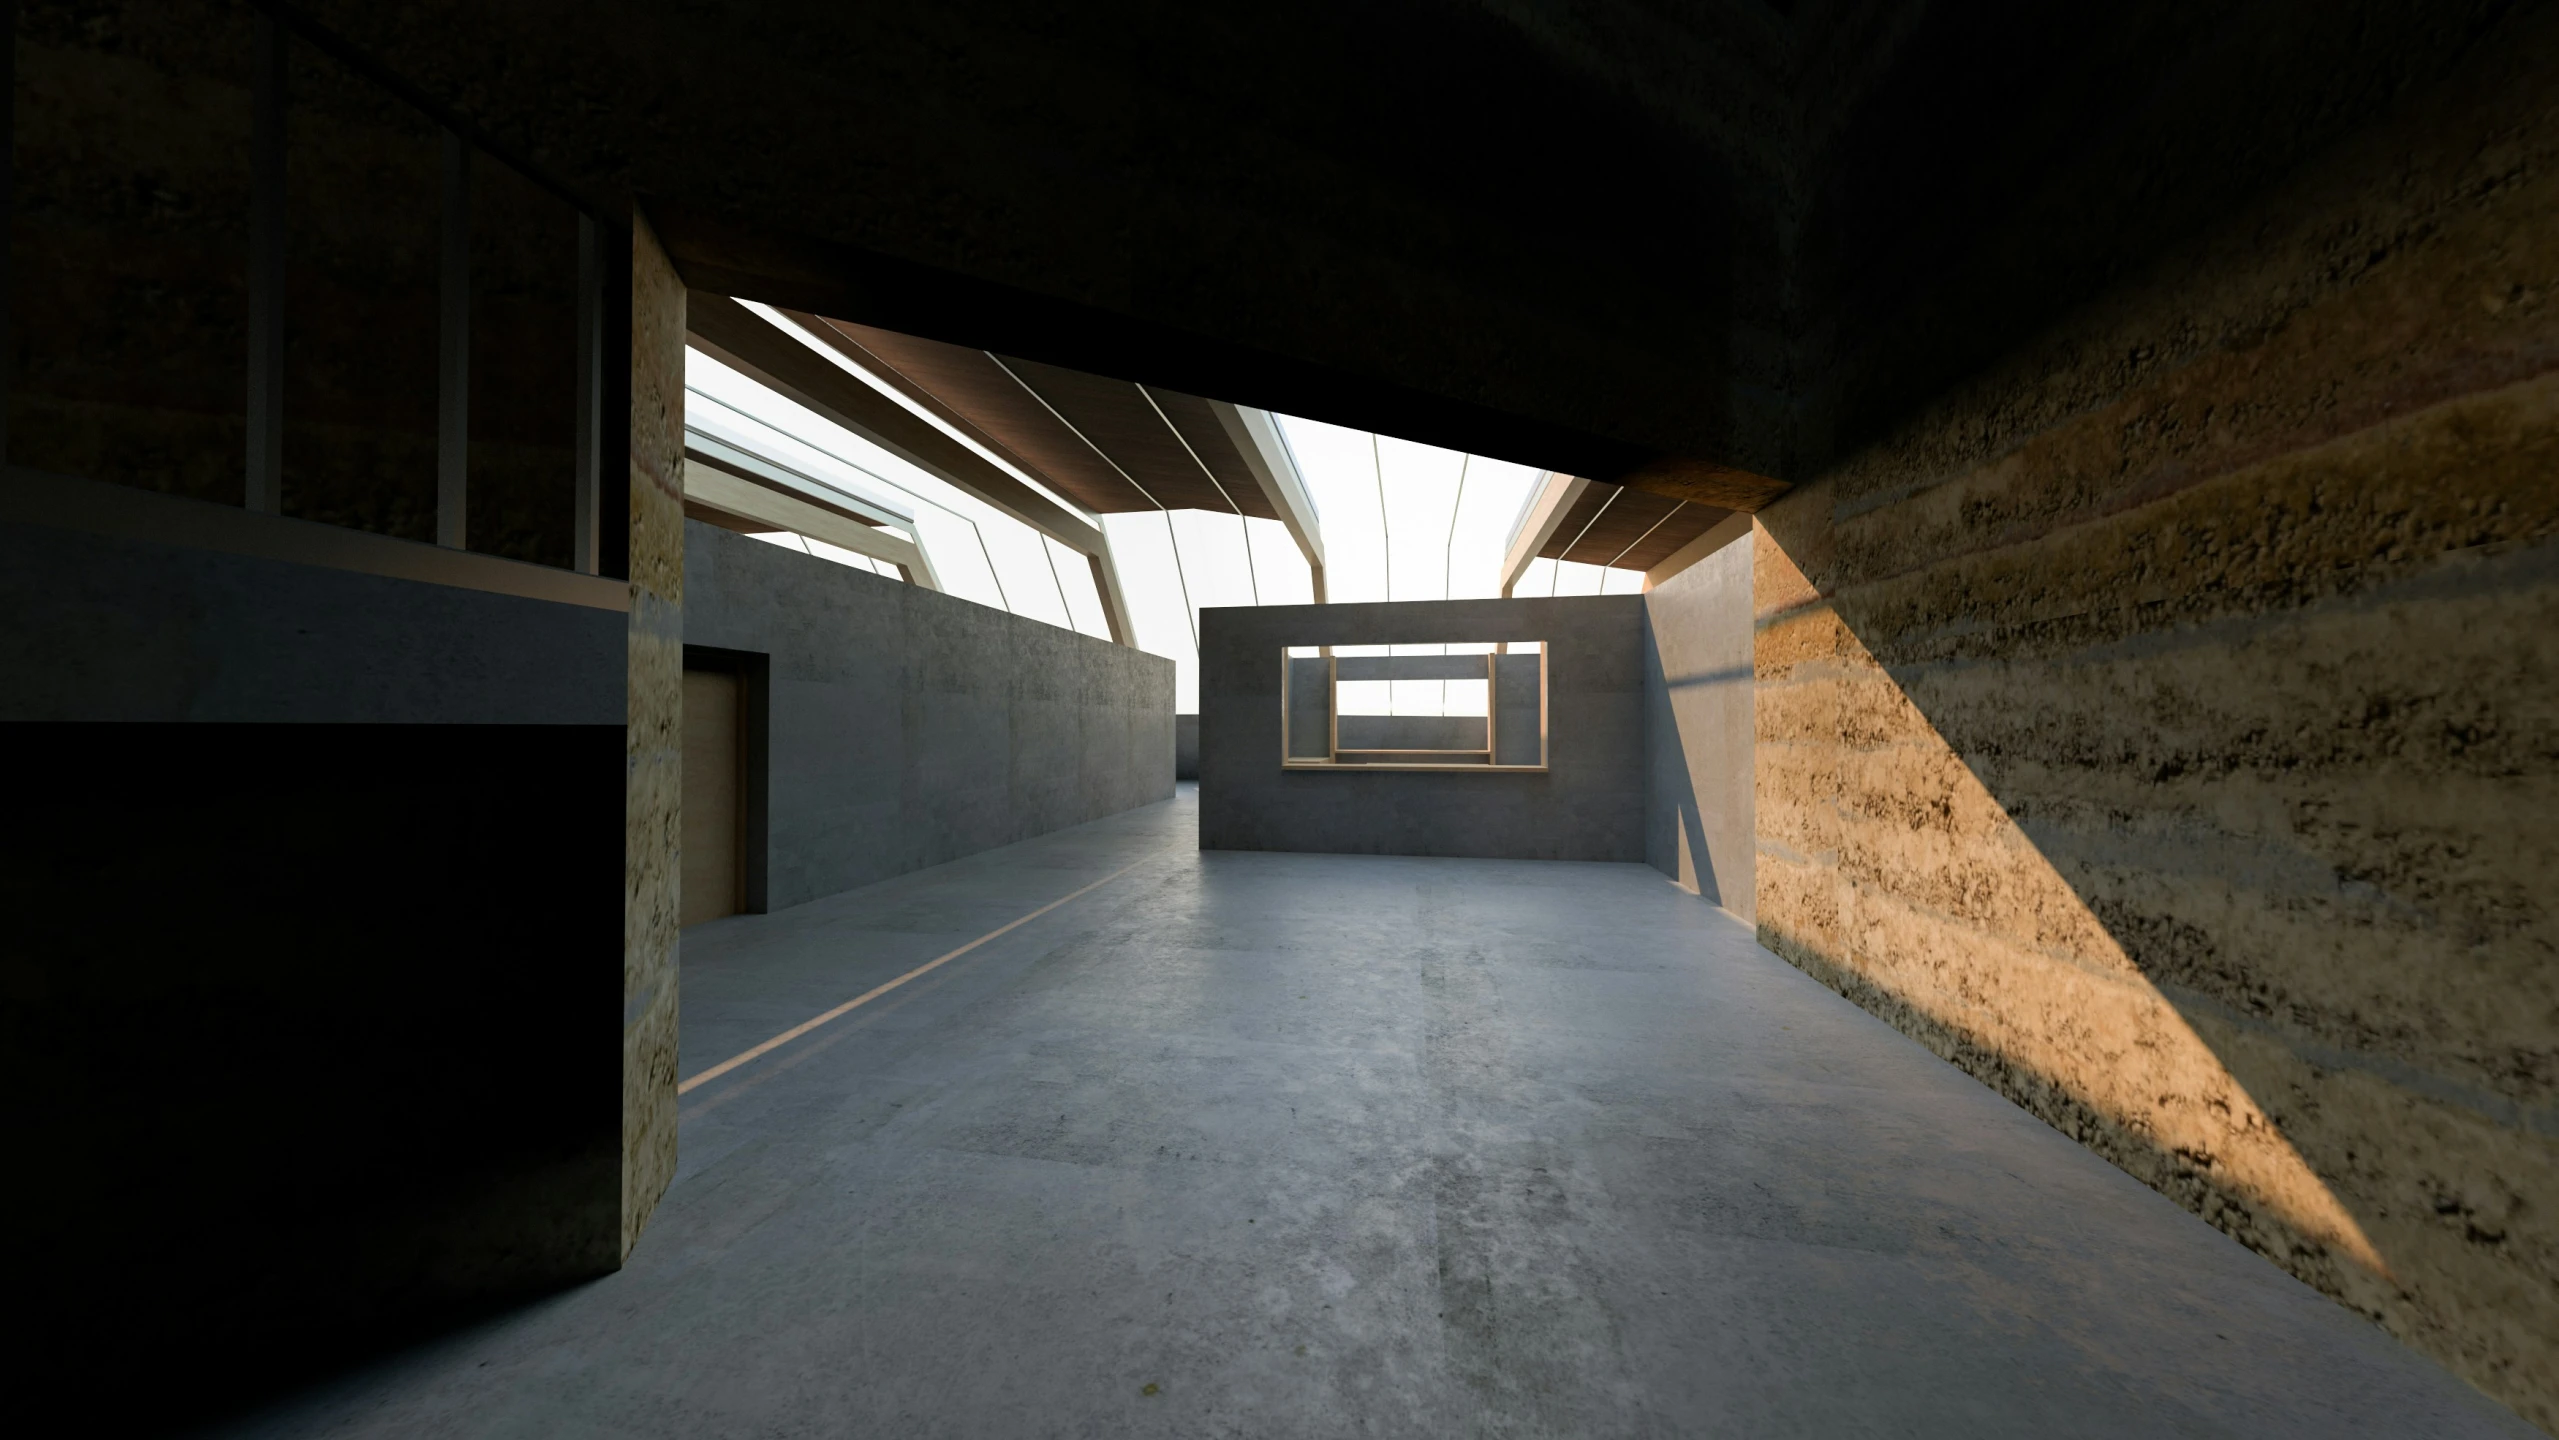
[1200,596,1645,859]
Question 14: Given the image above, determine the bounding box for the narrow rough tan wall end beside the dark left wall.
[622,215,683,1258]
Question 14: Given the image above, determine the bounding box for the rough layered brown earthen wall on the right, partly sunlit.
[1755,10,2559,1430]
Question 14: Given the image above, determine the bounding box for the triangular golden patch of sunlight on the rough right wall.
[1755,532,2395,1283]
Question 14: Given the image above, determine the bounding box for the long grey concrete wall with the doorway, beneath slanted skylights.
[683,522,1172,911]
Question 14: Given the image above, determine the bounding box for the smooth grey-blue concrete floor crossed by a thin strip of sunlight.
[220,785,2536,1440]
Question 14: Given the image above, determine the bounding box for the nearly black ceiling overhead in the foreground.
[297,0,2515,504]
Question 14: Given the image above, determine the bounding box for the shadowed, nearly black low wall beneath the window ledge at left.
[0,471,627,1427]
